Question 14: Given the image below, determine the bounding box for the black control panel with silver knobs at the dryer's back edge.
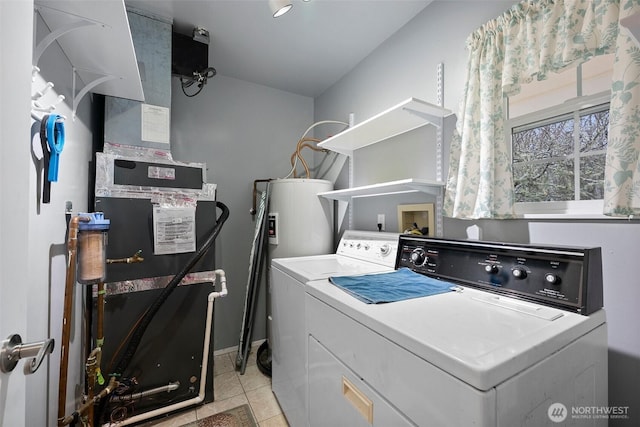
[396,235,602,315]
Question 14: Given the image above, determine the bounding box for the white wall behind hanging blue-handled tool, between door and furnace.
[34,44,94,425]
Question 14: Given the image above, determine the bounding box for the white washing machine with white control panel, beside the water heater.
[270,230,399,427]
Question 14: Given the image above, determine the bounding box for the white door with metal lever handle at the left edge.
[0,0,41,427]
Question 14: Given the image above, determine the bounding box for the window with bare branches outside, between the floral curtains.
[507,55,613,216]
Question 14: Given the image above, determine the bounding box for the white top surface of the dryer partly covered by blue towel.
[307,280,605,390]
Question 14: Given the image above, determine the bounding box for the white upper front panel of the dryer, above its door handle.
[305,294,496,427]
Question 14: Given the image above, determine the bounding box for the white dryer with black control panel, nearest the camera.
[306,236,608,427]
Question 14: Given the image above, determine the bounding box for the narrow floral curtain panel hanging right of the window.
[604,0,640,216]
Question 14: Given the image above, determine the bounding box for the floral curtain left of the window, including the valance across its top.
[444,0,620,219]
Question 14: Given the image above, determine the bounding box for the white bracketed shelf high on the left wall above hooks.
[33,0,144,113]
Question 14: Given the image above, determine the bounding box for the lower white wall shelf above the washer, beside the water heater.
[318,179,444,202]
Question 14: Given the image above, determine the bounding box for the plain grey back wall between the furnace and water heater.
[171,75,313,350]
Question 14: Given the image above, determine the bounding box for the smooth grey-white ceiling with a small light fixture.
[125,0,432,97]
